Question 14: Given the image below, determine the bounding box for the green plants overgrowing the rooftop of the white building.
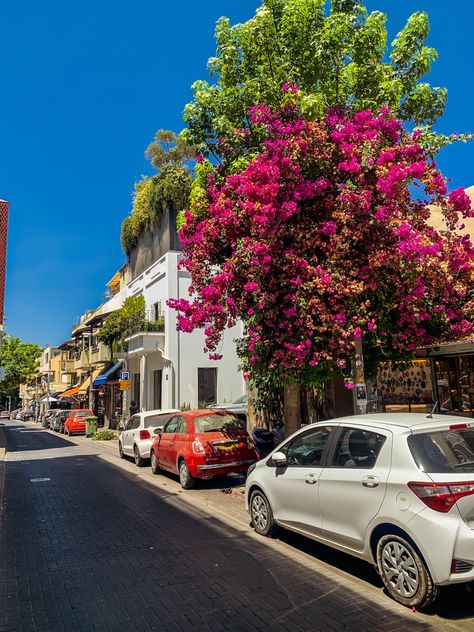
[121,130,196,254]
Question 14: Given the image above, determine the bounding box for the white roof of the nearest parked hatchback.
[306,413,471,432]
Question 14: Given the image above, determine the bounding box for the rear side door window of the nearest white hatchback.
[331,427,387,470]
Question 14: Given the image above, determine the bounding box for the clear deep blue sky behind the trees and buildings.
[0,0,474,345]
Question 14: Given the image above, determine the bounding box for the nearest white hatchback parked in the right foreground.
[245,413,474,608]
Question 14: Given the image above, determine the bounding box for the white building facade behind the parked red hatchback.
[122,250,245,410]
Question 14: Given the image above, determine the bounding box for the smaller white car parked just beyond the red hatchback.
[119,408,180,467]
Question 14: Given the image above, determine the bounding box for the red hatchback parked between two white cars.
[150,410,259,489]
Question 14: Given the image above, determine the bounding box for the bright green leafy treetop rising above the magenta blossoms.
[184,0,451,164]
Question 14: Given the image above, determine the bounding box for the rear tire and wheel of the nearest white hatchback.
[377,535,439,610]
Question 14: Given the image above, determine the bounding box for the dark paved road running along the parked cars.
[0,422,466,632]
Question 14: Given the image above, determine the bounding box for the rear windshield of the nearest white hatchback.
[408,428,474,474]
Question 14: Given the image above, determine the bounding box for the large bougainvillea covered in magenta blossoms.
[170,91,474,412]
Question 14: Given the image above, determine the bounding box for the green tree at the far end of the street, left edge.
[0,335,42,394]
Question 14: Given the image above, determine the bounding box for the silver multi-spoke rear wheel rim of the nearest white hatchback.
[382,540,420,599]
